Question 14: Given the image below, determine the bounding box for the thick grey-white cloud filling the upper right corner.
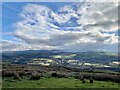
[77,2,118,32]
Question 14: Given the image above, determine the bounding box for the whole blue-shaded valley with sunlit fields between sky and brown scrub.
[2,50,120,71]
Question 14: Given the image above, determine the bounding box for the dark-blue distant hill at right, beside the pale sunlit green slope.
[74,51,118,64]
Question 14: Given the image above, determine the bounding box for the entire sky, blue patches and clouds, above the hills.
[1,2,119,52]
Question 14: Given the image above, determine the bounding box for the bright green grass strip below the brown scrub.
[2,78,120,88]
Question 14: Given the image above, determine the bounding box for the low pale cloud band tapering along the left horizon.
[0,40,55,51]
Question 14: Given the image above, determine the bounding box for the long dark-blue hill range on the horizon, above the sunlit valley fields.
[2,50,118,64]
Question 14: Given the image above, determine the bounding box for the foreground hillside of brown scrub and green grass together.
[2,64,120,88]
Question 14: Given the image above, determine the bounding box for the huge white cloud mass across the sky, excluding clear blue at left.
[3,2,118,51]
